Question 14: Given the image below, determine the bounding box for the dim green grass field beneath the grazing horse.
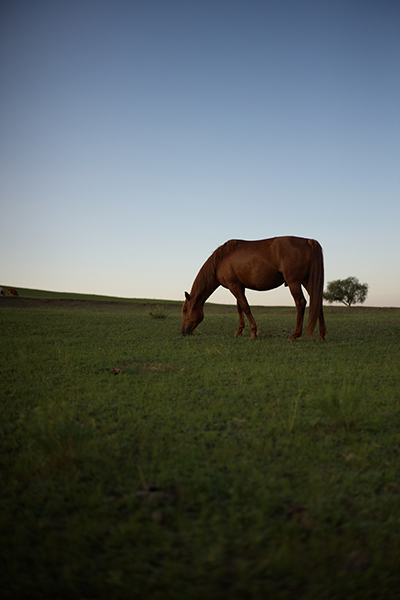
[0,290,400,600]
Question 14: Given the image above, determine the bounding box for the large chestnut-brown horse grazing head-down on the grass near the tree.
[181,236,327,340]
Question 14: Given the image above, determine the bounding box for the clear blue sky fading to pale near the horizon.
[0,0,400,306]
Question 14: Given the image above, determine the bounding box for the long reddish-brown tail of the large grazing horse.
[306,240,326,339]
